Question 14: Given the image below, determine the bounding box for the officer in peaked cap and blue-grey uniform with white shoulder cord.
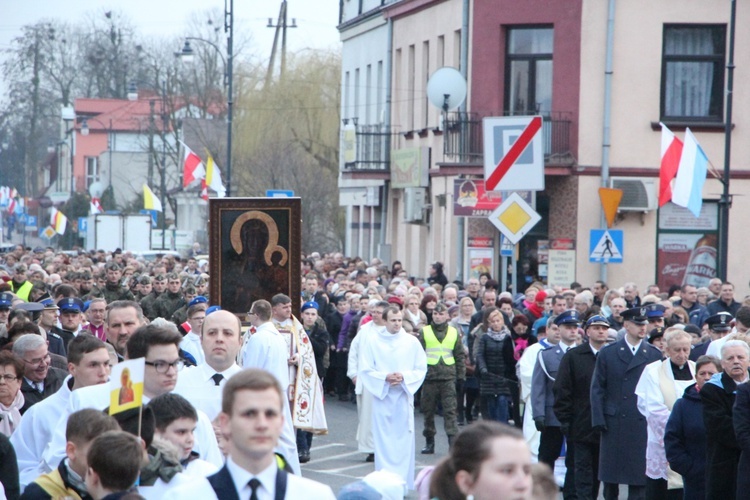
[531,309,580,498]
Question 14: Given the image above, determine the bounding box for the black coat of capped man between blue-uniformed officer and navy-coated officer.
[552,343,599,444]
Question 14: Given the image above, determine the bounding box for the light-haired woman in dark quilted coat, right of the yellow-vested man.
[472,307,516,423]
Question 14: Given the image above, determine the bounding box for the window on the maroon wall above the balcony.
[505,27,554,115]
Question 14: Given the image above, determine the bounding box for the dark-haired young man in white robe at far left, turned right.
[10,335,110,491]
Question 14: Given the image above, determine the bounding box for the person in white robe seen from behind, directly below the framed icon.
[241,300,301,474]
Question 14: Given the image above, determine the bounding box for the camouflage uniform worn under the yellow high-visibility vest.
[418,322,466,440]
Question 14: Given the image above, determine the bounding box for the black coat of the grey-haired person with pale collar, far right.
[700,372,740,500]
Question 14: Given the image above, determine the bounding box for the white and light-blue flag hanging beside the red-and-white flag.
[672,129,708,217]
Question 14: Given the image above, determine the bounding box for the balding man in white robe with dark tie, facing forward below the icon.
[174,306,242,426]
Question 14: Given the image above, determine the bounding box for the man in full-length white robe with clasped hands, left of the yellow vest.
[359,307,427,489]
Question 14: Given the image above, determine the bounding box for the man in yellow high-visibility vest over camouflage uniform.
[418,302,466,455]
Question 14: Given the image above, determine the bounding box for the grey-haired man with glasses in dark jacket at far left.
[13,334,66,415]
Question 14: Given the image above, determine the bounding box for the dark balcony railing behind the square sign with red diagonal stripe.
[443,112,576,166]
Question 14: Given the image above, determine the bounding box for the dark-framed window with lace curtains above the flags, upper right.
[661,24,726,121]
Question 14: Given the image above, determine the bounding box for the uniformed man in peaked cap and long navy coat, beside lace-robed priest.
[591,307,662,500]
